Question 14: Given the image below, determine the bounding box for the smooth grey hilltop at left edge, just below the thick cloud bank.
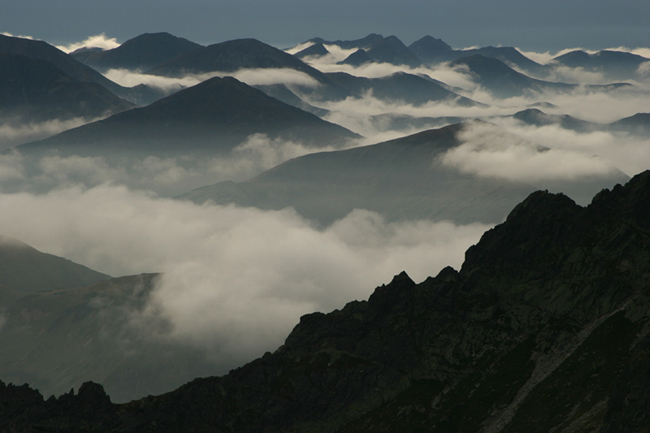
[0,236,111,292]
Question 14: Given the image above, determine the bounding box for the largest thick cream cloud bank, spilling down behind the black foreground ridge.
[0,185,488,368]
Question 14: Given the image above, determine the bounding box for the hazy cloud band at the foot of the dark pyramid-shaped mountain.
[0,134,355,196]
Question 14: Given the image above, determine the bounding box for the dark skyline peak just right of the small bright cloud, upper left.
[70,33,202,71]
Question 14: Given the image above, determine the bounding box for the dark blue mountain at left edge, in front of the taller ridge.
[0,54,133,124]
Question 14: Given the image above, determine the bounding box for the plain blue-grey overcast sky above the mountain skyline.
[0,0,650,51]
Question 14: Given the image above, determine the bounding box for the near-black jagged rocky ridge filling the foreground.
[0,172,650,432]
